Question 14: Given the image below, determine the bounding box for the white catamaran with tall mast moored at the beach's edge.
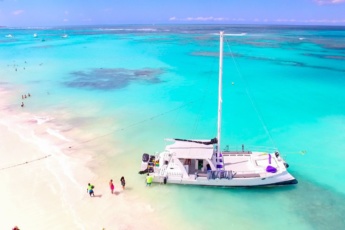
[139,32,297,187]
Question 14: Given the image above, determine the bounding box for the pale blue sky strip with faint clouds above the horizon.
[0,0,345,26]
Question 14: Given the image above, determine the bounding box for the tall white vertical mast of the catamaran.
[217,31,224,161]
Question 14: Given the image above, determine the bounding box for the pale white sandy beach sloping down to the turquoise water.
[0,86,171,229]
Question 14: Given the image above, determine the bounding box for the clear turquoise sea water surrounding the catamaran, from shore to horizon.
[0,26,345,229]
